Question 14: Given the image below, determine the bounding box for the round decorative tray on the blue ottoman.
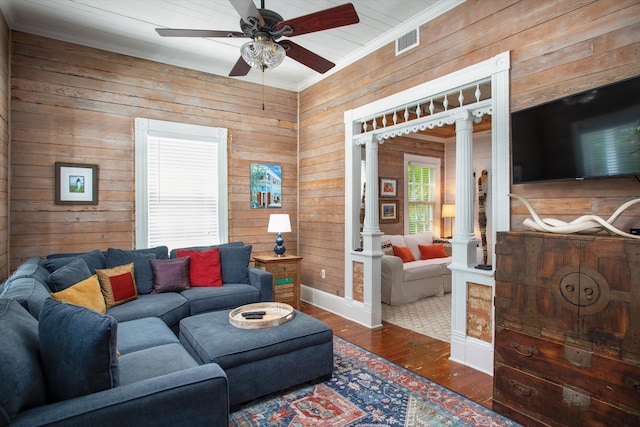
[229,302,295,329]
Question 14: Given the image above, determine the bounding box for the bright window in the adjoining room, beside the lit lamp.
[406,164,437,234]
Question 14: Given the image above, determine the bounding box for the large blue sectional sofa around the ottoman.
[0,243,272,427]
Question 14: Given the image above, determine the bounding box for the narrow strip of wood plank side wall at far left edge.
[0,11,11,280]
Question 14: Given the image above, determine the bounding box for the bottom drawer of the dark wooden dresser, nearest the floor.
[493,363,640,427]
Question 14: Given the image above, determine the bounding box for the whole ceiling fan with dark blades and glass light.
[156,0,360,77]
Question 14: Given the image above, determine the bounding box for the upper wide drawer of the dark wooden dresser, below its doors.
[495,329,640,412]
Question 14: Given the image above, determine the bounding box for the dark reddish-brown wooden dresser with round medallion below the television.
[493,232,640,426]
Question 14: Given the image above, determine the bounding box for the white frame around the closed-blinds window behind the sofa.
[134,117,229,249]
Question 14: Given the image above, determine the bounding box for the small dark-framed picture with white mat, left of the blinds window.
[55,162,98,205]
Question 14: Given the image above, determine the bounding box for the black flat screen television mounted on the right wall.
[511,76,640,184]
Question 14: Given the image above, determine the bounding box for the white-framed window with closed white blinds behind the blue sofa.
[136,119,227,248]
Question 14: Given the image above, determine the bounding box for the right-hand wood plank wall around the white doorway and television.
[299,0,640,295]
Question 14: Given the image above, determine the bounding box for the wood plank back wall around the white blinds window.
[7,32,298,269]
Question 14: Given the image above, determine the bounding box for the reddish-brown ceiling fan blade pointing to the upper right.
[276,3,360,37]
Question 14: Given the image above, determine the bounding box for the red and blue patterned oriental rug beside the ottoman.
[229,337,518,427]
